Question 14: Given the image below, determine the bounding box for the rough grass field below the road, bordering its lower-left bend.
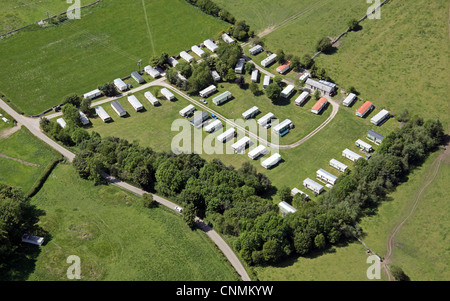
[27,165,237,281]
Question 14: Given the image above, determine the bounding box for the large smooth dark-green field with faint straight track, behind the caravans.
[0,0,228,115]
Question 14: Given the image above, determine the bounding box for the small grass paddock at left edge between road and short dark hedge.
[0,128,59,193]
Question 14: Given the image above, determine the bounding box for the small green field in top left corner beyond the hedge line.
[0,0,68,34]
